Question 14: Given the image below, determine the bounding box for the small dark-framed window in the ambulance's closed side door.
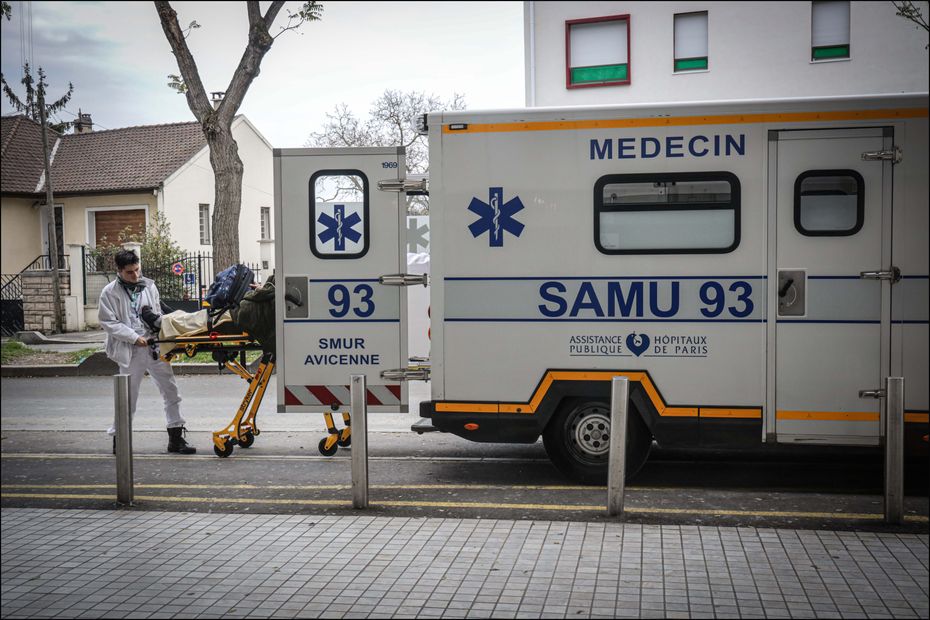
[794,170,865,237]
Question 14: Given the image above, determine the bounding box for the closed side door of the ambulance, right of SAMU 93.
[769,128,892,444]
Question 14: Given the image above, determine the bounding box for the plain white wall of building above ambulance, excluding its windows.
[524,2,930,106]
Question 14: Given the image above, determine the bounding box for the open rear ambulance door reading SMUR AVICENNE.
[275,148,407,412]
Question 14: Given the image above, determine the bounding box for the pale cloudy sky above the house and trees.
[0,1,524,148]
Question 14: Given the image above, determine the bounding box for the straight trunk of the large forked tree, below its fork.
[204,127,243,274]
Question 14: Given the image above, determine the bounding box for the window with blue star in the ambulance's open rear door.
[310,170,368,259]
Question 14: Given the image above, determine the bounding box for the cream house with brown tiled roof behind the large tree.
[0,114,274,278]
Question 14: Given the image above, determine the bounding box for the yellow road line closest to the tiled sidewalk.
[0,493,930,523]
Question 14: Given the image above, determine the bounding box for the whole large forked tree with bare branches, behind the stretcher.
[155,0,323,273]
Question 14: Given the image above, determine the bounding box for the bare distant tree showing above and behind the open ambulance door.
[306,89,465,215]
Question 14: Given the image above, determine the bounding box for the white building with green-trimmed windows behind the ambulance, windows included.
[524,0,928,107]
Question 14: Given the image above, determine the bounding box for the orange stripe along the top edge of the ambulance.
[442,108,927,134]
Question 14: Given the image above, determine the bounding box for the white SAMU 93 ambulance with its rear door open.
[275,93,928,482]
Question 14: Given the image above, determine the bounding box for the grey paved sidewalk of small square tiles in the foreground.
[0,509,928,618]
